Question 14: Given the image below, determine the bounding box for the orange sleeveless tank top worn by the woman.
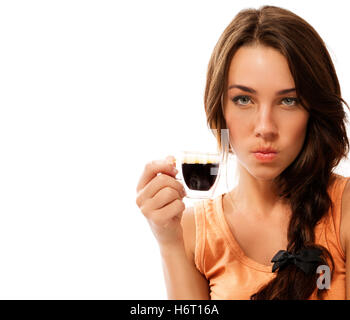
[194,174,350,300]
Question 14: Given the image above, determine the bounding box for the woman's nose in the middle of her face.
[255,105,278,139]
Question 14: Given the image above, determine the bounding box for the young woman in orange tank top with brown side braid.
[136,6,350,299]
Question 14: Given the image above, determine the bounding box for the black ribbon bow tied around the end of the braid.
[271,248,324,274]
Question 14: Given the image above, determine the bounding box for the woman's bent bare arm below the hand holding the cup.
[160,207,210,300]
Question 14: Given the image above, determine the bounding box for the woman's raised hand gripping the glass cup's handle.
[136,156,185,246]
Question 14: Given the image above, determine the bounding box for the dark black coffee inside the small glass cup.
[182,162,219,191]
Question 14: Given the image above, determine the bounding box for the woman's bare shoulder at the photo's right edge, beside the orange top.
[340,179,350,253]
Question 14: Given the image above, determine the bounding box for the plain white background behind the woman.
[0,0,350,299]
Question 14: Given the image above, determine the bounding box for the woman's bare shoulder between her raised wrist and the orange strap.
[181,207,196,261]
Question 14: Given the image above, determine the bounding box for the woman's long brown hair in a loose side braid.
[204,6,349,300]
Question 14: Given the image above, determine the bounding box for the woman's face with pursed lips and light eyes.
[224,46,309,180]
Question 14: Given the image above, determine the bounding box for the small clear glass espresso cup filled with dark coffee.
[176,151,221,199]
